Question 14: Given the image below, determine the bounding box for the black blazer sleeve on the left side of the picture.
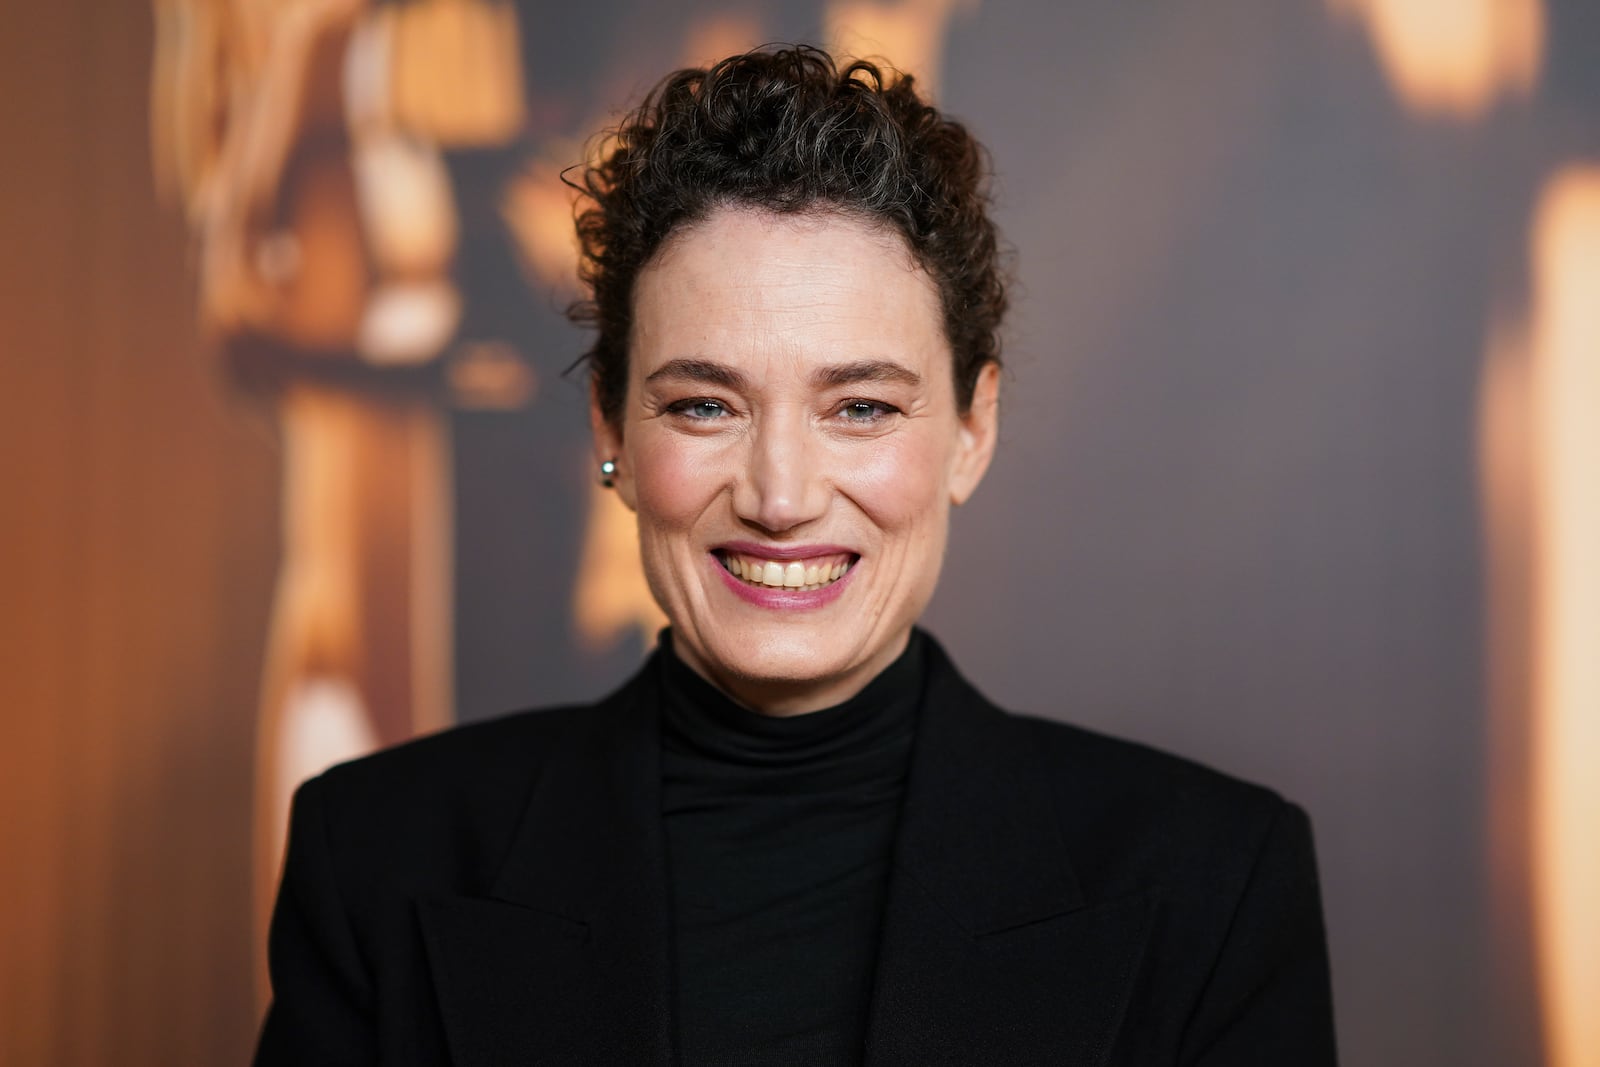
[254,777,378,1067]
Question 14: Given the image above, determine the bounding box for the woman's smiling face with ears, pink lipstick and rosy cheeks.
[594,208,998,713]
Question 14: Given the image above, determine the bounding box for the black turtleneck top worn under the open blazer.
[661,630,923,1067]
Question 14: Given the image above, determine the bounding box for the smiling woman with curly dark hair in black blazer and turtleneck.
[258,48,1334,1067]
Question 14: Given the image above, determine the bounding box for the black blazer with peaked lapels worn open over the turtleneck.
[256,641,1334,1067]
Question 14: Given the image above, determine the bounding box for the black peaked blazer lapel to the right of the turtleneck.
[867,641,1155,1067]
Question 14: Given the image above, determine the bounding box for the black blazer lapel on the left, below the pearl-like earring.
[418,665,670,1067]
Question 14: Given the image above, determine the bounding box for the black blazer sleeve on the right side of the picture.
[1179,803,1338,1067]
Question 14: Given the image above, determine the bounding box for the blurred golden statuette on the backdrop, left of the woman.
[152,0,531,992]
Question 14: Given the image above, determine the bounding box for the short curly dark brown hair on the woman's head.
[568,45,1006,424]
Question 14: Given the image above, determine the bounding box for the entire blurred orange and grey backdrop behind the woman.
[0,0,1600,1067]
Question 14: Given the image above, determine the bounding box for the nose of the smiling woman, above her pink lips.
[733,410,827,534]
